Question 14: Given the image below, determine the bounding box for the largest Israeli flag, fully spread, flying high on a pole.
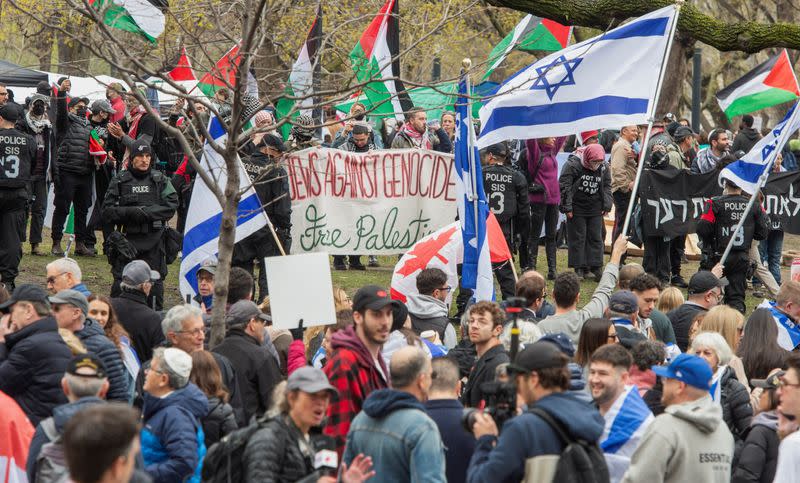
[478,5,678,148]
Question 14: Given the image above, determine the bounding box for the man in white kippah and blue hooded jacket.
[141,347,208,481]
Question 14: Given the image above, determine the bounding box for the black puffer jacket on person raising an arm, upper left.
[56,92,94,175]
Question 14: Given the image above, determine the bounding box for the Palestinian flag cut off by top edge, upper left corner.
[89,0,169,43]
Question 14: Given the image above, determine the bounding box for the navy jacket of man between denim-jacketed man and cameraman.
[425,399,475,483]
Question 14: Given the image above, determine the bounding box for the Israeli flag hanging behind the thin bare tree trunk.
[179,117,269,299]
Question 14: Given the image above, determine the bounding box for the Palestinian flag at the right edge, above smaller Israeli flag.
[717,49,800,119]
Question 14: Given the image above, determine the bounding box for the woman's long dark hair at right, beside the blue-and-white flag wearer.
[736,309,789,379]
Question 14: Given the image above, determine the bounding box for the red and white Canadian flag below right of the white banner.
[390,213,511,304]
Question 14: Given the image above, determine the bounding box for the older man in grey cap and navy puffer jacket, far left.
[50,289,131,402]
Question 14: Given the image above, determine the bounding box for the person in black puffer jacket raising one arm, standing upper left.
[50,83,95,257]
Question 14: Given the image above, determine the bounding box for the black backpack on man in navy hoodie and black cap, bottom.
[529,407,609,483]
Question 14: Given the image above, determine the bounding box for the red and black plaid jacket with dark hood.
[323,326,389,458]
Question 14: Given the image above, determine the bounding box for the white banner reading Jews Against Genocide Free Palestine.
[283,148,456,255]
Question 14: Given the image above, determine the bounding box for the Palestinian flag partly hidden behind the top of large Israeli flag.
[483,14,572,80]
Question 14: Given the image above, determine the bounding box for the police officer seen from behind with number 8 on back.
[697,179,769,313]
